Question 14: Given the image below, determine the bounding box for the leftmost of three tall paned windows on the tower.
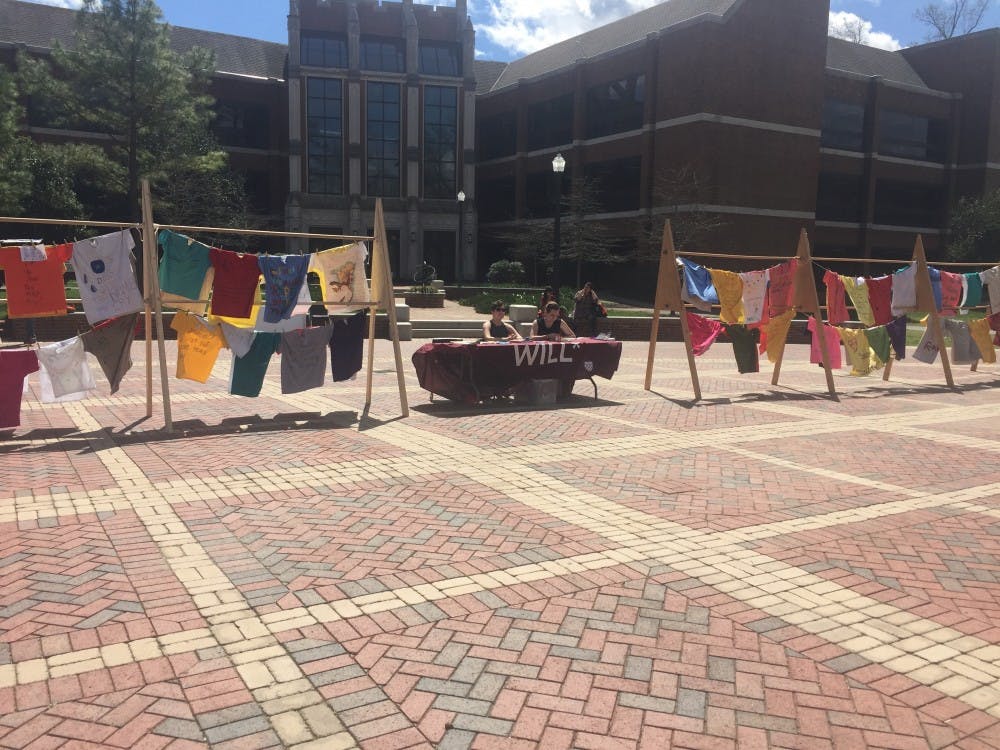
[306,78,344,195]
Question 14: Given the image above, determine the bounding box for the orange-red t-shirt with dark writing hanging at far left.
[0,245,73,318]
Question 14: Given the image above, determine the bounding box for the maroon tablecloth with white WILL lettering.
[413,339,622,403]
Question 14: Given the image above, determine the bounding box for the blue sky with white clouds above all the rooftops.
[27,0,1000,61]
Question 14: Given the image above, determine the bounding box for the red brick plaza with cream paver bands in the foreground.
[0,341,1000,750]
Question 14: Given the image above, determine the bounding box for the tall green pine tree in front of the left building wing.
[19,0,246,223]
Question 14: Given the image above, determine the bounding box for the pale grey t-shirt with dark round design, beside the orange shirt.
[70,230,143,325]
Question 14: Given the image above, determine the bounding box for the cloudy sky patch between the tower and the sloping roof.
[470,0,662,55]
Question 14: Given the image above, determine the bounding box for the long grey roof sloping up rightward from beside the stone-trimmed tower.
[476,0,740,94]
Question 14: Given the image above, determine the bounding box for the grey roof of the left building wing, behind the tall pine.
[0,0,288,78]
